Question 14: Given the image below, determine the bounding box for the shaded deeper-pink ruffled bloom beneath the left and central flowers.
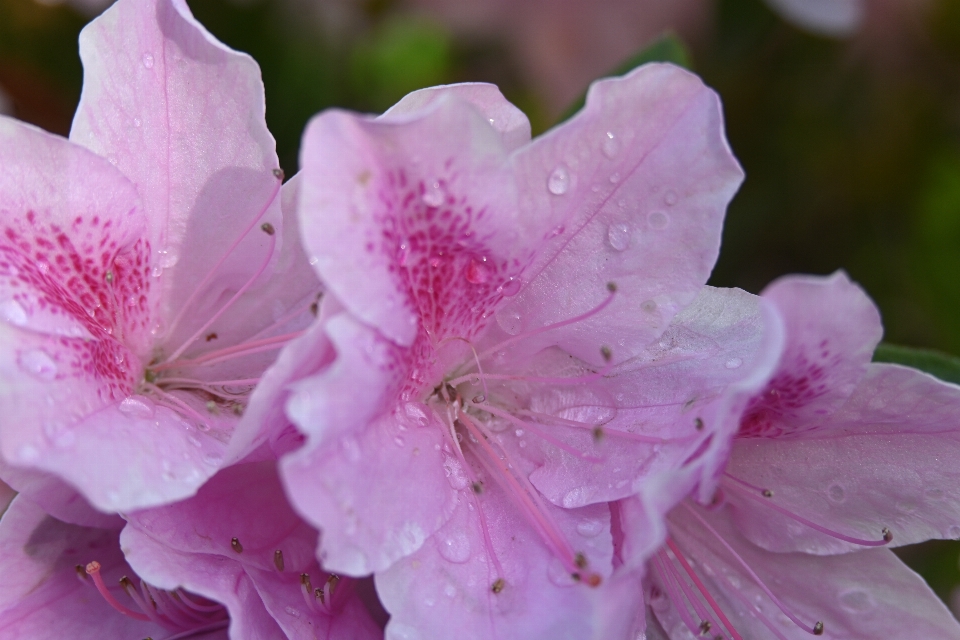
[120,460,383,640]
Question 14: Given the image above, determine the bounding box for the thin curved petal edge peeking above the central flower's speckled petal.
[381,82,530,150]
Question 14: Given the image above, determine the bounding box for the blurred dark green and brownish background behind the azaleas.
[0,0,960,611]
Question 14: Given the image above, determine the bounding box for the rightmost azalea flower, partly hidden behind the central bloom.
[622,274,960,640]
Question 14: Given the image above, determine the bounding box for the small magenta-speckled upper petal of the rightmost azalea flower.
[739,272,883,437]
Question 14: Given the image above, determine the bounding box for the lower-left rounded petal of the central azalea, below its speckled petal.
[281,403,455,576]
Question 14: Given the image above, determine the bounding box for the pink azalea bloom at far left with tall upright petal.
[0,0,320,524]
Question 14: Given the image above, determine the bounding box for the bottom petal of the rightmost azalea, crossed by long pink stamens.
[651,503,960,640]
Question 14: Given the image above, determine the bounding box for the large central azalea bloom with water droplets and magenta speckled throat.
[274,65,752,638]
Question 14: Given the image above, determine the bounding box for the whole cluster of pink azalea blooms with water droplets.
[0,0,960,640]
